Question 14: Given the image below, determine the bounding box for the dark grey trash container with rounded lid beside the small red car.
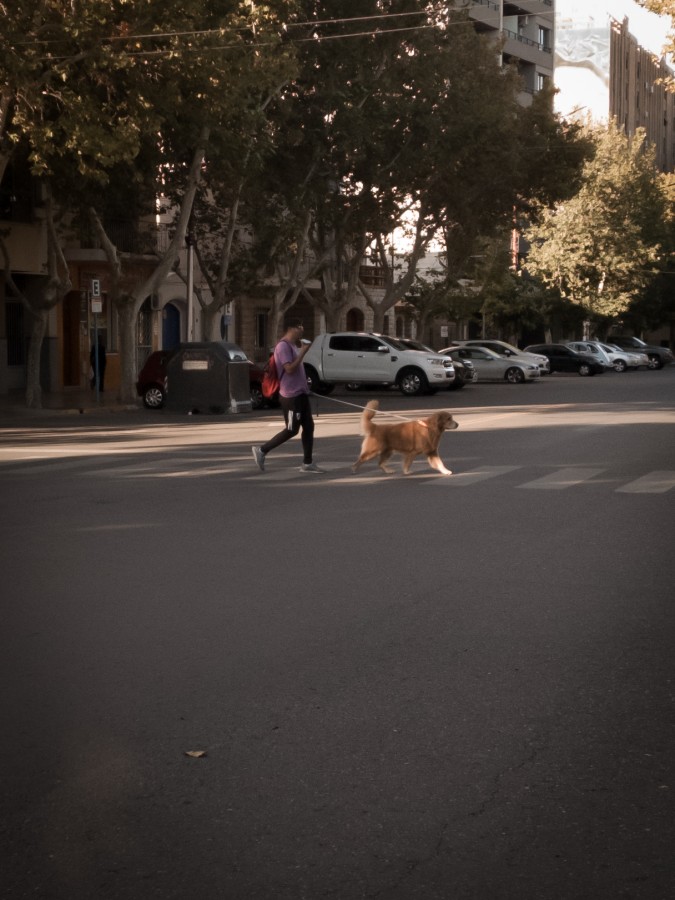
[165,341,251,413]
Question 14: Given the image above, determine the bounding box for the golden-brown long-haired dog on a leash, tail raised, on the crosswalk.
[352,400,459,475]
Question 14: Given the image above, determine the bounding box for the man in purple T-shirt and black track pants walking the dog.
[251,319,324,474]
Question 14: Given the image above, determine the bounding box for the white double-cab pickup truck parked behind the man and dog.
[303,331,455,397]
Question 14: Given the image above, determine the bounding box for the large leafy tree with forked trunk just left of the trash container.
[0,0,293,401]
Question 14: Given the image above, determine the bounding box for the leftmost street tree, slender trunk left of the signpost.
[0,0,164,407]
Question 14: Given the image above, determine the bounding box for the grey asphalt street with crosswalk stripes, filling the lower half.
[0,367,675,900]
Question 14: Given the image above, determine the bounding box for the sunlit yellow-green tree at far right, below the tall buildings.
[526,124,667,319]
